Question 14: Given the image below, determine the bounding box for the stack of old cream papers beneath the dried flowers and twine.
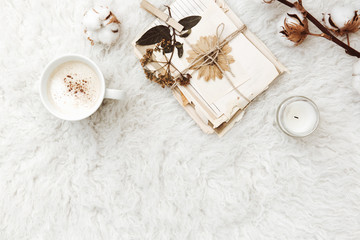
[134,0,286,136]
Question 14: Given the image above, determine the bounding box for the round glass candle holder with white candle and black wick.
[276,96,320,137]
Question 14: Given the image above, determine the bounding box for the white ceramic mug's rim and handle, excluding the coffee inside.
[40,54,125,121]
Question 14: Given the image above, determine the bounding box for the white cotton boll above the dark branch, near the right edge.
[323,6,360,36]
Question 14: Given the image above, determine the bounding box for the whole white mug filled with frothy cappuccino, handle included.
[40,54,126,121]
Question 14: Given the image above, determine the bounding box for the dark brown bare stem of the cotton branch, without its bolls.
[277,0,360,58]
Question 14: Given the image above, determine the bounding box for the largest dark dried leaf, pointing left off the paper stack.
[136,25,171,46]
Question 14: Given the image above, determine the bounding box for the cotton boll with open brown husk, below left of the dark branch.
[279,9,309,46]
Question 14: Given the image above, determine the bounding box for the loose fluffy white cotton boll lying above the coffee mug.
[82,6,120,45]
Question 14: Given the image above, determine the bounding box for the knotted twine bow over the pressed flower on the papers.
[173,23,251,103]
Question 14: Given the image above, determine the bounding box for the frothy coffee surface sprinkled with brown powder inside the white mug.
[48,61,101,116]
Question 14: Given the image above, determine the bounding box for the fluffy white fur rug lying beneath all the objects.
[0,0,360,240]
